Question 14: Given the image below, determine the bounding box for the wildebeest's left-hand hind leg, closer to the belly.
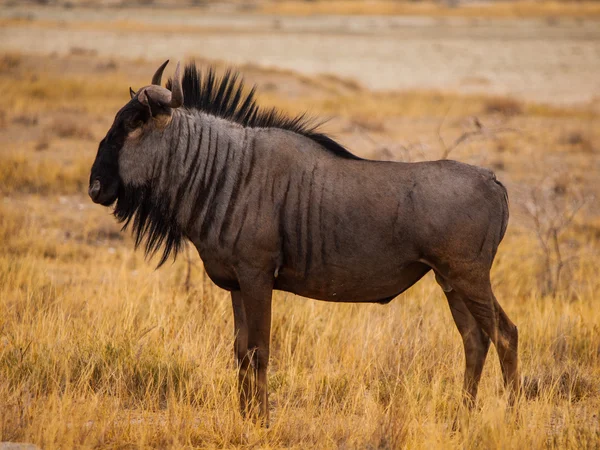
[436,274,490,408]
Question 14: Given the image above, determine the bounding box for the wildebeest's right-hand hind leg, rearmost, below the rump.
[450,268,519,405]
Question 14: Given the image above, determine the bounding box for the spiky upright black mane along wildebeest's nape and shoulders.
[167,63,362,159]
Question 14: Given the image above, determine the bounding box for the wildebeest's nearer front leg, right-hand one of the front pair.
[239,273,273,427]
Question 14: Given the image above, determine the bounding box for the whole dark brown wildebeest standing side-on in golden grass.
[89,61,519,423]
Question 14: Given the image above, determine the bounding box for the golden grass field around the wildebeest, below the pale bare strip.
[0,35,600,449]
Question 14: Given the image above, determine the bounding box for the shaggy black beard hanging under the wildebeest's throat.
[113,183,184,268]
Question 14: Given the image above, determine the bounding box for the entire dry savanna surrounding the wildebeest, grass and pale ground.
[0,0,600,448]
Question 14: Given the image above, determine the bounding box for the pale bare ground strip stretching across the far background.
[0,7,600,104]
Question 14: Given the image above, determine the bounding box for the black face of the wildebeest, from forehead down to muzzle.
[88,98,151,206]
